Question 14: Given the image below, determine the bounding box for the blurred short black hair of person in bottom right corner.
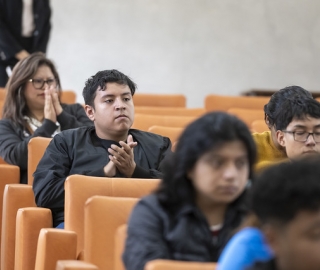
[250,156,320,225]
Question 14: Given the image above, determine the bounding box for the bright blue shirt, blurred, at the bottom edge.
[217,227,273,270]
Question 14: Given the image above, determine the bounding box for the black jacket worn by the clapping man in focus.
[33,127,171,227]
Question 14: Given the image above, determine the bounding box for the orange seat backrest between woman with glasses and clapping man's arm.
[28,137,52,186]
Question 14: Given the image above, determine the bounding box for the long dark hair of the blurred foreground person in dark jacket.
[156,112,256,208]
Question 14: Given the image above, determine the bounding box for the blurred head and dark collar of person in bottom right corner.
[250,155,320,270]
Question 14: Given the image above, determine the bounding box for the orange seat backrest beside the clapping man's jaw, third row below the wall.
[132,114,197,131]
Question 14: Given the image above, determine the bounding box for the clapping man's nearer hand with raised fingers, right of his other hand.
[108,135,137,177]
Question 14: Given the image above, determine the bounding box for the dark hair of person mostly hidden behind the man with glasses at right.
[264,85,312,126]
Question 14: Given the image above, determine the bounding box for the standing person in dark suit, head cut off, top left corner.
[0,0,51,87]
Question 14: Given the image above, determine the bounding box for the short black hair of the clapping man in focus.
[82,69,136,107]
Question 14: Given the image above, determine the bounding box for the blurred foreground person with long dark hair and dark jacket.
[123,112,256,270]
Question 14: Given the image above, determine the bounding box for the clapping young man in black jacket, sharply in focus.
[33,70,171,228]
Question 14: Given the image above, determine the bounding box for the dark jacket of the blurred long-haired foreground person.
[123,194,247,270]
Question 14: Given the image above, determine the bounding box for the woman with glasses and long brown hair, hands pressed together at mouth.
[0,53,92,183]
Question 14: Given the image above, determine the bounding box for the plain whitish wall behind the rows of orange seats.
[48,0,320,107]
